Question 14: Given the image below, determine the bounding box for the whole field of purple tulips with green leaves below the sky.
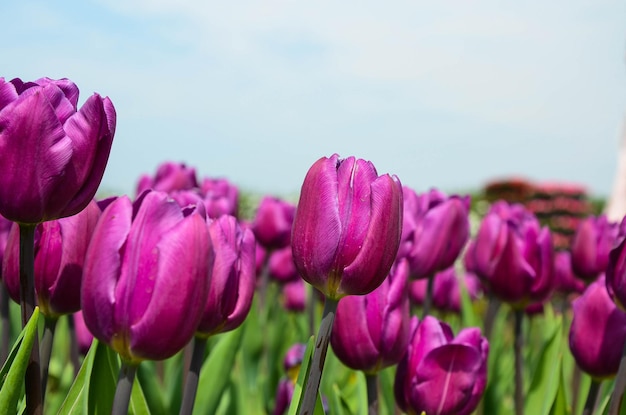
[0,78,626,415]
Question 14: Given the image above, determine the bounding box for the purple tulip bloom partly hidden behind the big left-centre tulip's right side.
[196,215,256,337]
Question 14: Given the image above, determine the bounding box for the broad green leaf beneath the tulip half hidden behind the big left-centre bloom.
[193,327,243,414]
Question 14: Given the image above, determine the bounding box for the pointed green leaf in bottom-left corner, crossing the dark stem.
[0,307,39,414]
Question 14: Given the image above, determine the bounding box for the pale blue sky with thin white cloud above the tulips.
[0,0,626,195]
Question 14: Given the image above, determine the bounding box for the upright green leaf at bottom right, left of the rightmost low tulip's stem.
[524,317,563,415]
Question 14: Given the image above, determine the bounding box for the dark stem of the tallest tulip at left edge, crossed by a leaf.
[19,223,43,415]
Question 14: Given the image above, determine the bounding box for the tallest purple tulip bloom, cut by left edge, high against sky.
[0,78,116,224]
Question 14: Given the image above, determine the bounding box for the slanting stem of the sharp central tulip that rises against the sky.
[299,298,339,415]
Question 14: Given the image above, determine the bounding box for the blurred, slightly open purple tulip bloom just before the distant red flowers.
[469,201,554,309]
